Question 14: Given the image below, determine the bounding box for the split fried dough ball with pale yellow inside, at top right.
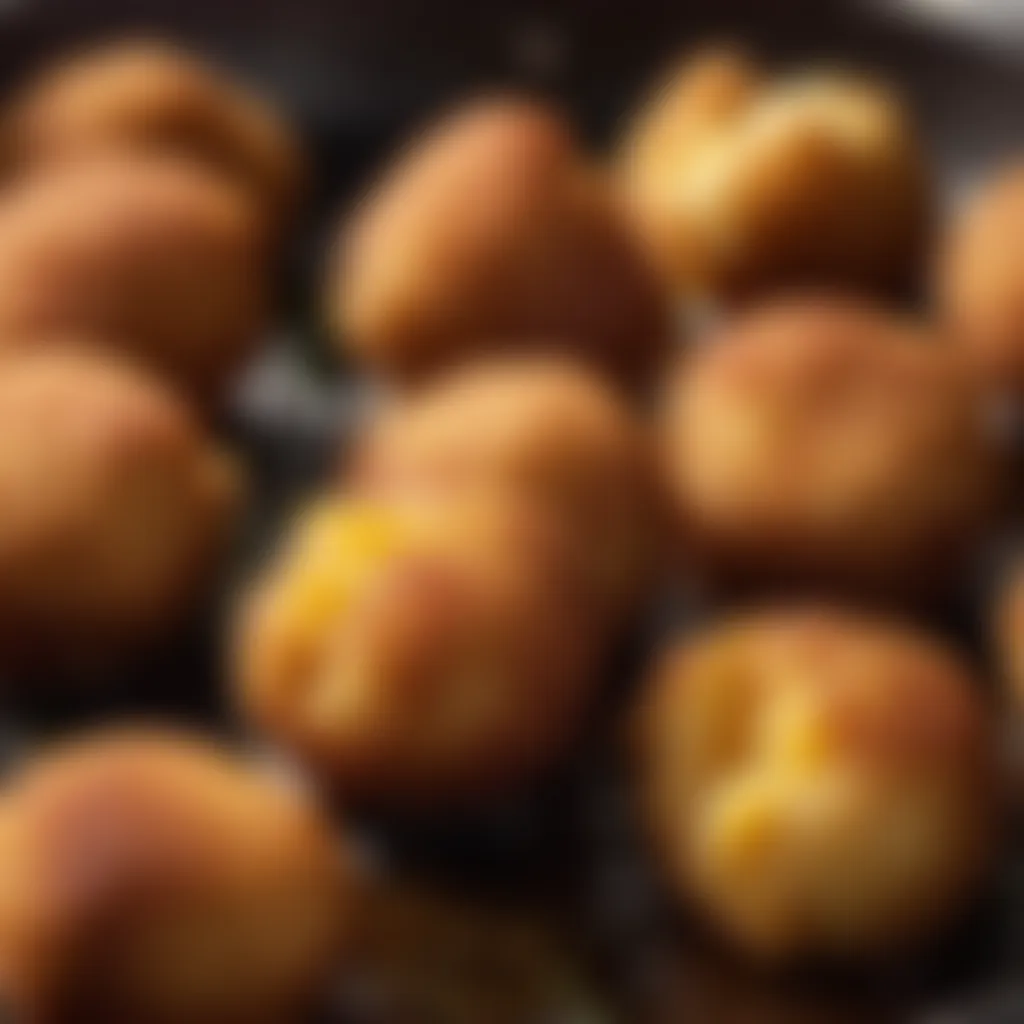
[622,51,931,303]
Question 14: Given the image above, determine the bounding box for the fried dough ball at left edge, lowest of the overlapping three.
[0,348,240,675]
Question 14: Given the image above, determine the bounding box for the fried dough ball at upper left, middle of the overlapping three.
[0,157,266,402]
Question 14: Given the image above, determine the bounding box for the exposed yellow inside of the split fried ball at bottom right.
[690,680,948,952]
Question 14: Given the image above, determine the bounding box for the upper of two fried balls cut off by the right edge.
[934,163,1024,396]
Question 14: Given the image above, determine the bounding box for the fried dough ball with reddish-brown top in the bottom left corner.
[0,730,352,1024]
